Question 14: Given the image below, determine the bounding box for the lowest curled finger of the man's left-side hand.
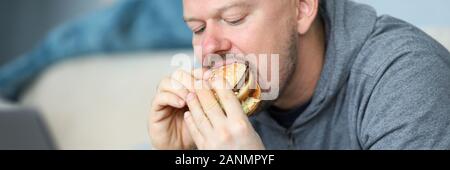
[153,92,185,111]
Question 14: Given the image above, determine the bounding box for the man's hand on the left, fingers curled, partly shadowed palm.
[148,69,209,150]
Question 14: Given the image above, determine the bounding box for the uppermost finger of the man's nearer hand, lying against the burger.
[210,76,245,119]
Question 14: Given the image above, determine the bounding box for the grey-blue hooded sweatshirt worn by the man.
[250,0,450,149]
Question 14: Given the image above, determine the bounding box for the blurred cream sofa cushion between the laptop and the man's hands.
[21,51,192,149]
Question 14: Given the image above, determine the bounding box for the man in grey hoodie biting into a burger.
[149,0,450,149]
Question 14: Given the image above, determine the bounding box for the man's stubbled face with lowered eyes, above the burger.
[183,0,298,107]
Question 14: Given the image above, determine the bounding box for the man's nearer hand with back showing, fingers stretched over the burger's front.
[185,75,264,150]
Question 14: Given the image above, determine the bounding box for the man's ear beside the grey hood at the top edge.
[296,0,320,35]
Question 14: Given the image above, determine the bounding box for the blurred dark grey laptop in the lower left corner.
[0,108,57,150]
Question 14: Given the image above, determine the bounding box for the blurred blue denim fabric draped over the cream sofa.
[0,0,192,101]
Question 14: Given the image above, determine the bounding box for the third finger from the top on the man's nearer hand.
[186,93,212,136]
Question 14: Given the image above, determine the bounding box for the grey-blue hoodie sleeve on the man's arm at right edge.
[359,52,450,149]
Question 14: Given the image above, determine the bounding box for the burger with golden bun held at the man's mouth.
[211,62,261,116]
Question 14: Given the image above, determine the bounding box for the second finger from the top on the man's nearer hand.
[196,81,226,128]
